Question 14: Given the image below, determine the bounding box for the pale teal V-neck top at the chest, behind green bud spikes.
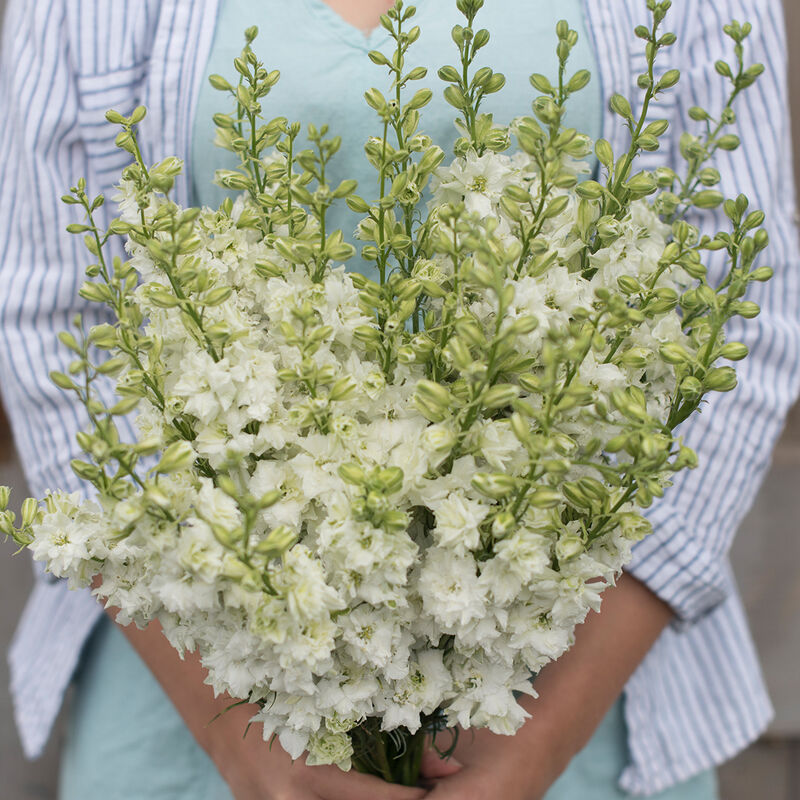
[190,0,602,282]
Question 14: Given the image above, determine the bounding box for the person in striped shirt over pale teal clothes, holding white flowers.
[0,0,800,800]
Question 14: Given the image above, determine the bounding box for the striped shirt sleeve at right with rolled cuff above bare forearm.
[630,0,800,624]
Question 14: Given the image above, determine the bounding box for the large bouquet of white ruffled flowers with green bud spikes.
[0,0,771,785]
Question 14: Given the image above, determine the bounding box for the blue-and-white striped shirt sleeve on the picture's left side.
[0,0,144,506]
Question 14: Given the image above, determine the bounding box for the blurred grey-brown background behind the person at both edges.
[0,0,800,800]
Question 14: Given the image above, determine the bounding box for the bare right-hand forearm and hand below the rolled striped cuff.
[426,575,672,800]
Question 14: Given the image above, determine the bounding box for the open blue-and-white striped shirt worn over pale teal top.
[0,0,800,795]
